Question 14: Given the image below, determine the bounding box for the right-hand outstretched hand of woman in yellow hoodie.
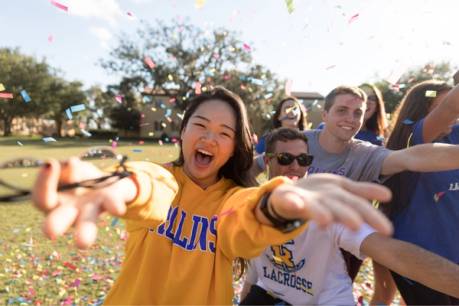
[270,174,392,235]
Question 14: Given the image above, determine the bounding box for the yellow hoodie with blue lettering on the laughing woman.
[105,162,304,305]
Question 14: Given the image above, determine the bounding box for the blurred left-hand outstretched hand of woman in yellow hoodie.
[32,158,137,248]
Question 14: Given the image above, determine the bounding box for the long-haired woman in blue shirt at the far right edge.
[385,80,459,305]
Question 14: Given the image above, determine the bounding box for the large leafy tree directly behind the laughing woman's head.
[101,21,281,134]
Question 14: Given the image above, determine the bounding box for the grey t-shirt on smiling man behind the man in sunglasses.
[305,130,391,182]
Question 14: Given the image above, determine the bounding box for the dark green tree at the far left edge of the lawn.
[0,48,54,136]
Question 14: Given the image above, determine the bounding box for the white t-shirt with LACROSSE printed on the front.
[247,222,375,305]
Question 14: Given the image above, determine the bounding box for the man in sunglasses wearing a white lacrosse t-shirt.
[240,128,459,305]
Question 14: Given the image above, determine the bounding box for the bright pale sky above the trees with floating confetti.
[0,0,459,95]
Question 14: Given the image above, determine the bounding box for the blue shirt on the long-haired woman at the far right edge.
[392,120,459,263]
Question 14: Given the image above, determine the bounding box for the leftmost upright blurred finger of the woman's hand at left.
[32,160,61,212]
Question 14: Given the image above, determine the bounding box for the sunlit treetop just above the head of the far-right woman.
[375,62,452,113]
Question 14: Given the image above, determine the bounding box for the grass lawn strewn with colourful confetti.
[0,138,398,305]
